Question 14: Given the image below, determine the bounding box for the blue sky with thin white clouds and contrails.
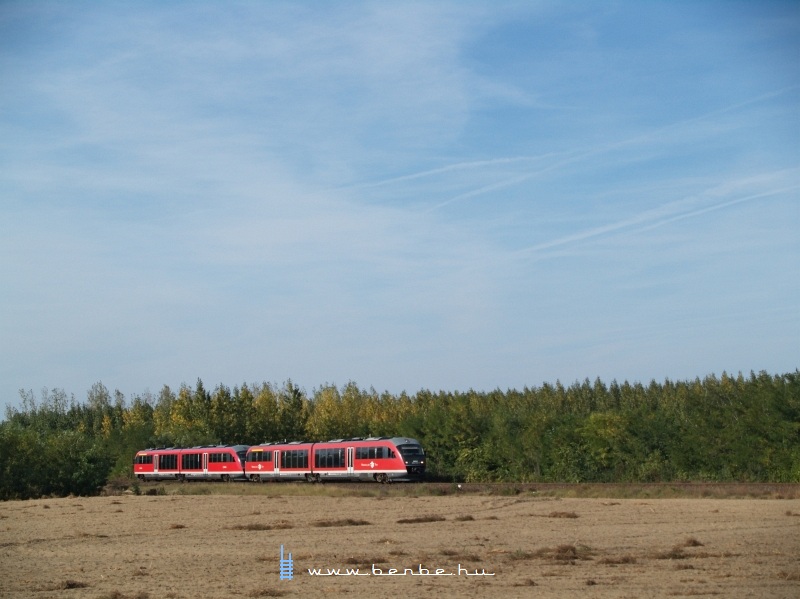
[0,0,800,406]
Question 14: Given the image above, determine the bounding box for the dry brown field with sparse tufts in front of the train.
[0,486,800,599]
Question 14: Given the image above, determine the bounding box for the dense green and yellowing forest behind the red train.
[0,370,800,500]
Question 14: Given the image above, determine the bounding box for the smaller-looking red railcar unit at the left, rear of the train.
[133,445,247,481]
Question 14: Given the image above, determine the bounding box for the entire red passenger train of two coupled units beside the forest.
[134,437,425,483]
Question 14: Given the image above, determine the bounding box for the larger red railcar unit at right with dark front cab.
[245,437,425,483]
